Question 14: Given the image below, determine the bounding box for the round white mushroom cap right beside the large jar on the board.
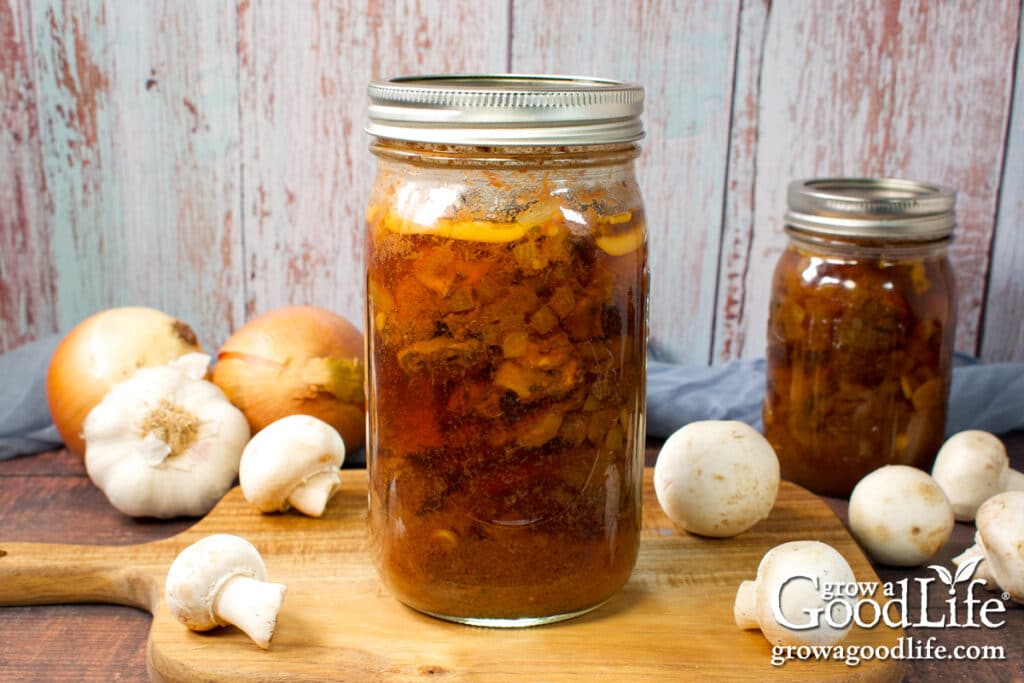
[654,420,779,538]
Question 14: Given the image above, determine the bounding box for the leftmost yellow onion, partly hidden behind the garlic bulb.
[46,306,203,456]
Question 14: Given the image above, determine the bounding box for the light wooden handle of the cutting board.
[0,541,161,612]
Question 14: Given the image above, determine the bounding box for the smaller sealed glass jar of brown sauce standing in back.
[764,178,956,497]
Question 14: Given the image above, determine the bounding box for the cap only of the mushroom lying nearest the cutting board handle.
[164,533,266,631]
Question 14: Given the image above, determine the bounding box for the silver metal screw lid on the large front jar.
[367,74,643,145]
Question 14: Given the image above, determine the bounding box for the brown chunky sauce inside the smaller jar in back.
[764,240,953,495]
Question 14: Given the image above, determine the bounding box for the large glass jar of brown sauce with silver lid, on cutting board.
[367,76,648,627]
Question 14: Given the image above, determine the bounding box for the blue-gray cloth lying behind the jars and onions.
[0,336,1024,458]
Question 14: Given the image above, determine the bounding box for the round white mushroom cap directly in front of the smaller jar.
[849,465,954,566]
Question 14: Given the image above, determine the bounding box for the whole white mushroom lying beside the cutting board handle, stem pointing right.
[165,533,286,649]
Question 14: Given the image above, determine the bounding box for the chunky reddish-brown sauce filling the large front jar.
[368,180,646,618]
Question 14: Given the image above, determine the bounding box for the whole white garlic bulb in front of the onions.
[83,353,249,517]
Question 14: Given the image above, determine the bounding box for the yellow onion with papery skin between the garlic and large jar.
[213,306,366,451]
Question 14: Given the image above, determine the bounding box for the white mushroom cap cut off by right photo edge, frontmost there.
[975,490,1024,602]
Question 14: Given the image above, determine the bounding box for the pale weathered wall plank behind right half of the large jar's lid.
[512,0,739,364]
